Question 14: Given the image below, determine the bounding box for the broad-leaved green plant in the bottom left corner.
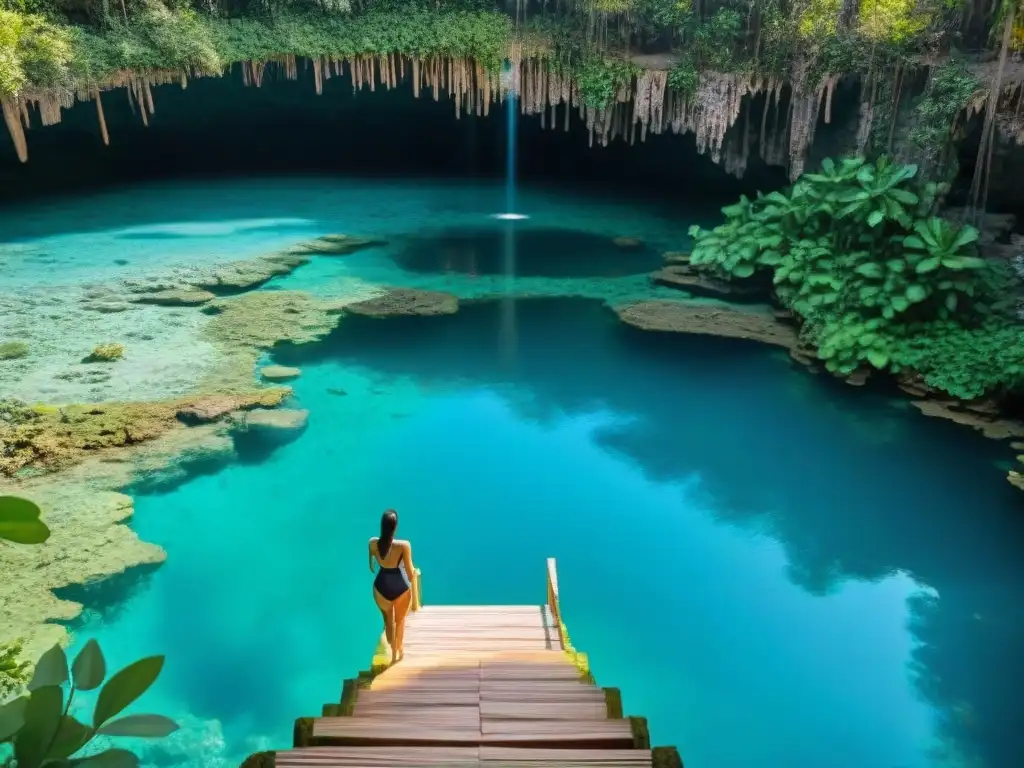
[0,640,178,768]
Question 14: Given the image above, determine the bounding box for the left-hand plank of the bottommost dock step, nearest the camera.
[274,746,480,768]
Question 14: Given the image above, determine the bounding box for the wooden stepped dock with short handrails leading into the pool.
[243,559,682,768]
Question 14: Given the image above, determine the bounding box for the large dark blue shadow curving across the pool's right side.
[275,296,1024,768]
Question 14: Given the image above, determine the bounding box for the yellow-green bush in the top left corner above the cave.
[0,9,72,97]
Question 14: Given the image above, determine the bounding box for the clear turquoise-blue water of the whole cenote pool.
[0,181,1024,768]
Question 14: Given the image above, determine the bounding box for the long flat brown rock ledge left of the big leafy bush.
[614,300,799,349]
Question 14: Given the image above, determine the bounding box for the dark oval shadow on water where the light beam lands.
[392,226,662,278]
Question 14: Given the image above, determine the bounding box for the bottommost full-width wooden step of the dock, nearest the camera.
[274,746,651,768]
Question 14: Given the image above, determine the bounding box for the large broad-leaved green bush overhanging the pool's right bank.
[691,158,1024,397]
